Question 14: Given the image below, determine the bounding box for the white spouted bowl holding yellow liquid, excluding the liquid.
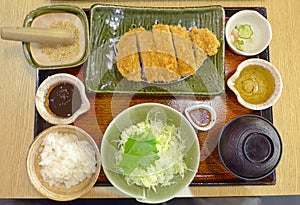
[227,58,283,110]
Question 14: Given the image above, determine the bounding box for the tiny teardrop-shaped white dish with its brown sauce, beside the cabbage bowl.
[185,104,217,131]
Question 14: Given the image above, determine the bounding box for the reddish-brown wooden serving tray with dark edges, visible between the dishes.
[34,7,276,186]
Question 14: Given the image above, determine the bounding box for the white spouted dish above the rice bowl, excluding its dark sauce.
[35,73,90,124]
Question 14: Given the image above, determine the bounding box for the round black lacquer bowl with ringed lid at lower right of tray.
[218,115,282,180]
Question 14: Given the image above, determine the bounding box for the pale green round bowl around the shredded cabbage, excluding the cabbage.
[101,103,200,203]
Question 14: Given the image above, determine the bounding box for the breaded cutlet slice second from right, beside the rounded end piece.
[170,26,196,76]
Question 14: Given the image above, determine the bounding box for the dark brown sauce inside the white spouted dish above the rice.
[48,82,82,117]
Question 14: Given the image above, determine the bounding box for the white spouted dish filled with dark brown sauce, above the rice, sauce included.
[35,73,90,124]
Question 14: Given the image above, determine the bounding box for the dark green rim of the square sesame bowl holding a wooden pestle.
[23,5,89,69]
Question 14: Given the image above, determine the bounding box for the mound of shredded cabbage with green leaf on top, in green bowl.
[116,112,187,191]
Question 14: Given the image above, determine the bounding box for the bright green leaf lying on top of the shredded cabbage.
[118,130,159,175]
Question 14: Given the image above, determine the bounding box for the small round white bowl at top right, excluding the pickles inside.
[225,10,272,56]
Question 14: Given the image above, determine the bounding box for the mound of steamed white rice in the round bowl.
[39,132,97,189]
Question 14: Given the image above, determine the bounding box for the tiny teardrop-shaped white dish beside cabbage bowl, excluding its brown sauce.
[185,104,217,131]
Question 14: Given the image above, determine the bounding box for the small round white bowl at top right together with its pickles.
[225,10,272,56]
